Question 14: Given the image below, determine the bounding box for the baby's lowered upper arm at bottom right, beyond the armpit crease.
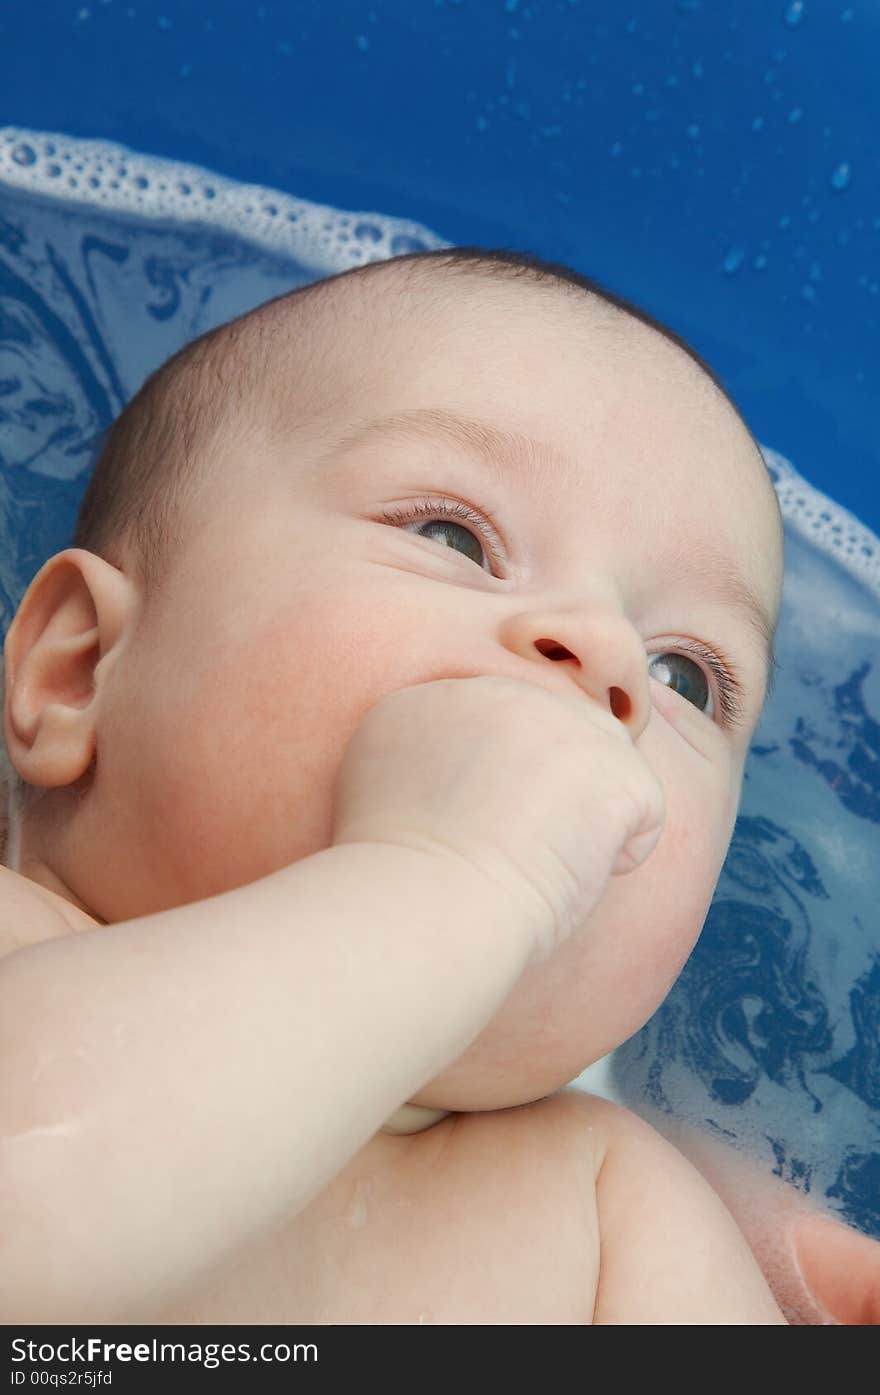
[590,1101,785,1325]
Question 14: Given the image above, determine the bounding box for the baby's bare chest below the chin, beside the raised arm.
[155,1104,598,1325]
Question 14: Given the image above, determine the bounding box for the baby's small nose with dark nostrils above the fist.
[503,607,651,741]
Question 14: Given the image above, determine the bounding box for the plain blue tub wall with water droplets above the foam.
[0,0,880,531]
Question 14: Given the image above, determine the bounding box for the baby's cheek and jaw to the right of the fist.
[420,753,727,1108]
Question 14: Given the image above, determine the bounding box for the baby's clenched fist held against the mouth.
[333,677,665,958]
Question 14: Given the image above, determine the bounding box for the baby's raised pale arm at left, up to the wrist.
[0,843,531,1322]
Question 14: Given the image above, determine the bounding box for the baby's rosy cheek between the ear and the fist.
[135,593,443,898]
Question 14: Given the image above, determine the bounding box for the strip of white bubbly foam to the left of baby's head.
[0,126,449,275]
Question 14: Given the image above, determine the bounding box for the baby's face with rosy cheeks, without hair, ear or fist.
[65,286,782,1109]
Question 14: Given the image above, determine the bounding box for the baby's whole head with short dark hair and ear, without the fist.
[4,248,782,1109]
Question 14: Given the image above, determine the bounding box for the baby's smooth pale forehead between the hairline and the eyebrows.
[317,276,773,527]
